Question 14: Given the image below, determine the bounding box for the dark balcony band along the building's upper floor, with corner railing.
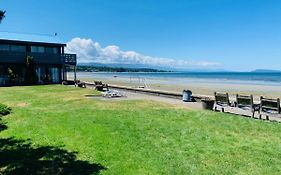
[0,51,77,66]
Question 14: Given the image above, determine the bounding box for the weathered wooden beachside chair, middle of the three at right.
[235,94,260,117]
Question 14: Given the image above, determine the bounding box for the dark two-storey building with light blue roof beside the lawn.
[0,35,77,86]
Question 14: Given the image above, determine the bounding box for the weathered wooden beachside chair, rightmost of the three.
[259,96,281,120]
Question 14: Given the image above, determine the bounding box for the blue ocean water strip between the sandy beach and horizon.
[78,72,281,86]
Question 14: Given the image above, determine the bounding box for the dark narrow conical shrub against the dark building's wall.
[24,56,38,85]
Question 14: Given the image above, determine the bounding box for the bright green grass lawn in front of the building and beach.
[0,85,281,175]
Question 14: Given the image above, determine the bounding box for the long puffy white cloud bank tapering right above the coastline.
[66,38,220,68]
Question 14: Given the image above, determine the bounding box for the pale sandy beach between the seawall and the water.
[69,72,281,100]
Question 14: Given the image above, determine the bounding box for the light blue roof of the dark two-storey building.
[0,32,65,46]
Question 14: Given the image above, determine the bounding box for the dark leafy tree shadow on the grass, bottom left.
[0,117,106,175]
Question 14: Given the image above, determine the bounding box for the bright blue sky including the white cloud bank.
[0,0,281,71]
